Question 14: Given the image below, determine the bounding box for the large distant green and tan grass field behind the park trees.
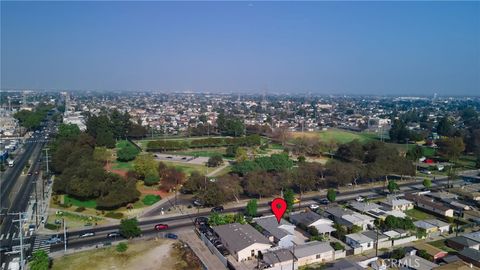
[292,129,377,144]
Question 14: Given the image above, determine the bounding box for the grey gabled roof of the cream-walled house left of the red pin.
[213,223,270,252]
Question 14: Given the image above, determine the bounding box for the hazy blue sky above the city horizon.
[1,1,480,95]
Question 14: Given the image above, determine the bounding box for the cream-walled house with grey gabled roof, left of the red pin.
[213,223,272,262]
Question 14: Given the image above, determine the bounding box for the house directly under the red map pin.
[253,215,296,247]
